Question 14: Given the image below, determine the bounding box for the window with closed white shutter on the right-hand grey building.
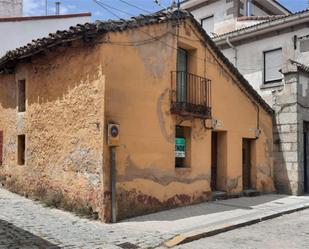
[264,48,283,84]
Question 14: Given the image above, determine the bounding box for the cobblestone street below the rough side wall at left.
[0,188,171,249]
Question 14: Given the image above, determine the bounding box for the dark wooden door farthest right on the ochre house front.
[242,138,252,190]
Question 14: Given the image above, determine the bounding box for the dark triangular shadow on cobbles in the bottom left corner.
[0,220,60,249]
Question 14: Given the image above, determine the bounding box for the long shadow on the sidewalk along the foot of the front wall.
[123,195,286,222]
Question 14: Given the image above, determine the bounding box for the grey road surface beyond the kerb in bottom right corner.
[176,209,309,249]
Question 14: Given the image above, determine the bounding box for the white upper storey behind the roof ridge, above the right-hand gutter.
[181,0,291,37]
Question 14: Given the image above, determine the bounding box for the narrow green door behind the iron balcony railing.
[176,48,188,103]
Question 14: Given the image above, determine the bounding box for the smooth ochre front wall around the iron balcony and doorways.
[101,22,274,219]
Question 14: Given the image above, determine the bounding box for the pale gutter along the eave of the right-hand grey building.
[213,11,309,46]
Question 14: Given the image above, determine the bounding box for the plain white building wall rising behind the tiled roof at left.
[0,13,91,56]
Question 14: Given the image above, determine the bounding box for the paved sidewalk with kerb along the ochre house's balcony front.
[127,194,309,247]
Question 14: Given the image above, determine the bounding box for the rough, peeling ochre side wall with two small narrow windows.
[0,44,104,217]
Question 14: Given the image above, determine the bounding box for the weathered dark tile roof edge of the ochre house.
[0,10,274,114]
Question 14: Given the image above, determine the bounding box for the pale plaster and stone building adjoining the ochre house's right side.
[182,0,309,195]
